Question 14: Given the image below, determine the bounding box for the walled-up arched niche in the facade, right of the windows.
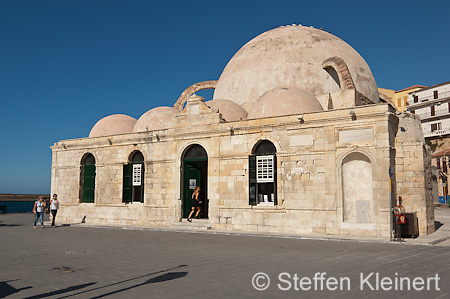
[340,151,375,223]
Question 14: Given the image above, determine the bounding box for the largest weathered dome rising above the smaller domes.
[213,25,379,110]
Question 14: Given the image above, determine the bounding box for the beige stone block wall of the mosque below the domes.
[52,102,434,237]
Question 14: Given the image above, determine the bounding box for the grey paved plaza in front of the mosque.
[0,208,450,298]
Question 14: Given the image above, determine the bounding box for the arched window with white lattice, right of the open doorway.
[248,140,277,205]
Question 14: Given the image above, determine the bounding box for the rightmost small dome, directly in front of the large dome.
[248,87,323,119]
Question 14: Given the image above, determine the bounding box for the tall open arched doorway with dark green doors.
[181,144,208,218]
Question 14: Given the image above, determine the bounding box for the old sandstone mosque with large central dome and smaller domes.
[51,25,434,238]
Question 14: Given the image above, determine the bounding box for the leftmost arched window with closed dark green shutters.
[80,153,95,203]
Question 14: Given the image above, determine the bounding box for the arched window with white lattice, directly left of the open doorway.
[122,151,144,203]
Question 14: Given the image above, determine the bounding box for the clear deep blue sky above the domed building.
[0,0,450,193]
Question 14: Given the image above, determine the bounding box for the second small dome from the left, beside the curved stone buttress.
[133,106,180,132]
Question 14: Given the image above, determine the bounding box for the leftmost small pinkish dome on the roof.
[89,114,137,137]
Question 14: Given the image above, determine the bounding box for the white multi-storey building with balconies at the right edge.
[407,81,450,201]
